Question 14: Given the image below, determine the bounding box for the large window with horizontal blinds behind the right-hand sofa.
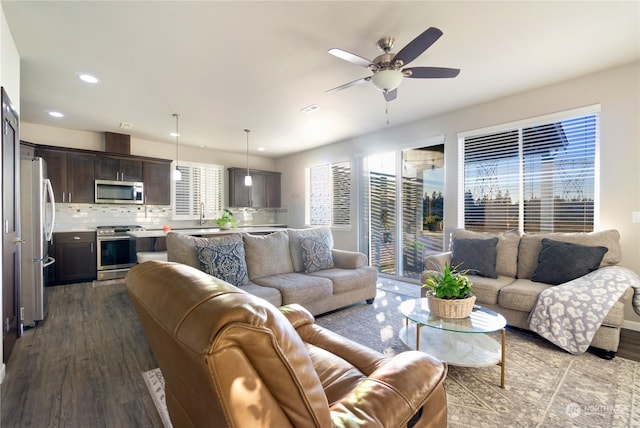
[459,107,599,232]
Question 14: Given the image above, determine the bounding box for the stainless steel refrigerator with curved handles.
[20,158,56,327]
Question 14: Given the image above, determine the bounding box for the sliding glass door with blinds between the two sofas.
[362,144,444,280]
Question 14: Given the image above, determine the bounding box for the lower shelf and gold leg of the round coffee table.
[399,319,506,388]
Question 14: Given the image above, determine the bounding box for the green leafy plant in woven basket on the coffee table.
[422,265,476,318]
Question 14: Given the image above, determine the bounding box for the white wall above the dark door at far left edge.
[0,0,20,383]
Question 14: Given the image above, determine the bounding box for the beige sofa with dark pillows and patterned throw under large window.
[422,229,633,358]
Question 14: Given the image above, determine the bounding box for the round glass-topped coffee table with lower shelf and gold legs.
[400,298,507,388]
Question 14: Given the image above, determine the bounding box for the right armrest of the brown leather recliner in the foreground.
[329,351,447,427]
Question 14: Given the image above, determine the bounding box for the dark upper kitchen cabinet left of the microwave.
[36,148,96,204]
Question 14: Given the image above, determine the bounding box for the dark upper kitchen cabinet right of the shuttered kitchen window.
[229,168,281,208]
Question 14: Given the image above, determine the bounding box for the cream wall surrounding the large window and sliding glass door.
[276,62,640,329]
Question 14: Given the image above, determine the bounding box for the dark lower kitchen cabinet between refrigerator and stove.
[51,232,97,284]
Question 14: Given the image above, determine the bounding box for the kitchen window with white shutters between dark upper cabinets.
[173,162,224,220]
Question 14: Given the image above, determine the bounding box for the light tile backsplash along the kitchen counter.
[54,203,288,232]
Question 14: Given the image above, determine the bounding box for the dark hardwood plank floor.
[0,283,640,428]
